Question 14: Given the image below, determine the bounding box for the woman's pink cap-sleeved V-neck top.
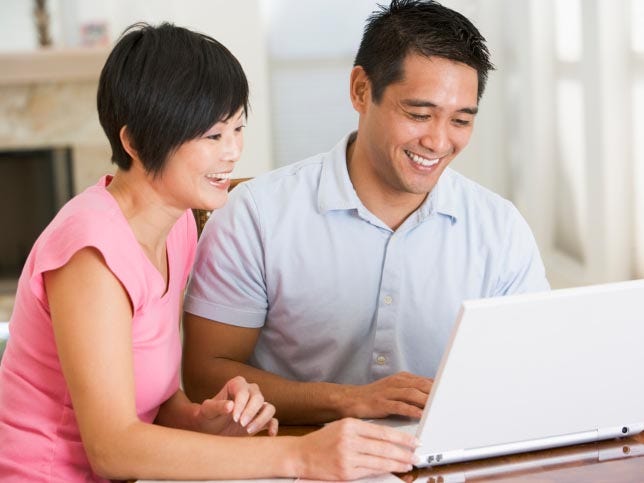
[0,176,197,482]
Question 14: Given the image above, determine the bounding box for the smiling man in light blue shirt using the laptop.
[184,0,549,423]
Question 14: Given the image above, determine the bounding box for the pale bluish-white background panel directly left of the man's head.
[263,0,377,166]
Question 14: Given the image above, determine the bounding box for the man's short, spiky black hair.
[354,0,494,102]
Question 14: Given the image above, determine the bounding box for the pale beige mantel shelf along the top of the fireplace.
[0,47,109,86]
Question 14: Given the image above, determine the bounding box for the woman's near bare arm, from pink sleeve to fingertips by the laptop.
[45,248,414,479]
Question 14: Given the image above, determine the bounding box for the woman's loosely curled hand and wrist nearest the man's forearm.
[194,376,278,436]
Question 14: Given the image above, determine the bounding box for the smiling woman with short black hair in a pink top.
[0,24,414,481]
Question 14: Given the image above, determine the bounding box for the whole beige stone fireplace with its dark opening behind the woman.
[0,48,113,291]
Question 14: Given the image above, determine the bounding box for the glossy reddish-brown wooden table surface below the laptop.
[280,426,644,483]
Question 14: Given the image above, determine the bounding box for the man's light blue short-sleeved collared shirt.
[185,136,549,384]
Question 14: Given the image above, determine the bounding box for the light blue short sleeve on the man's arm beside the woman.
[184,184,268,328]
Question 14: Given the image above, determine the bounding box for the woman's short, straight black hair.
[97,23,248,175]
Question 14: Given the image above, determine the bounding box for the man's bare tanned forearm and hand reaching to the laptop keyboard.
[183,312,432,424]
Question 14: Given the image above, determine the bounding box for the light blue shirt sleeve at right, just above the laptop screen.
[494,204,550,296]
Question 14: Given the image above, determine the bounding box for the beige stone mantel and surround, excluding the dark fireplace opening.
[0,48,113,193]
